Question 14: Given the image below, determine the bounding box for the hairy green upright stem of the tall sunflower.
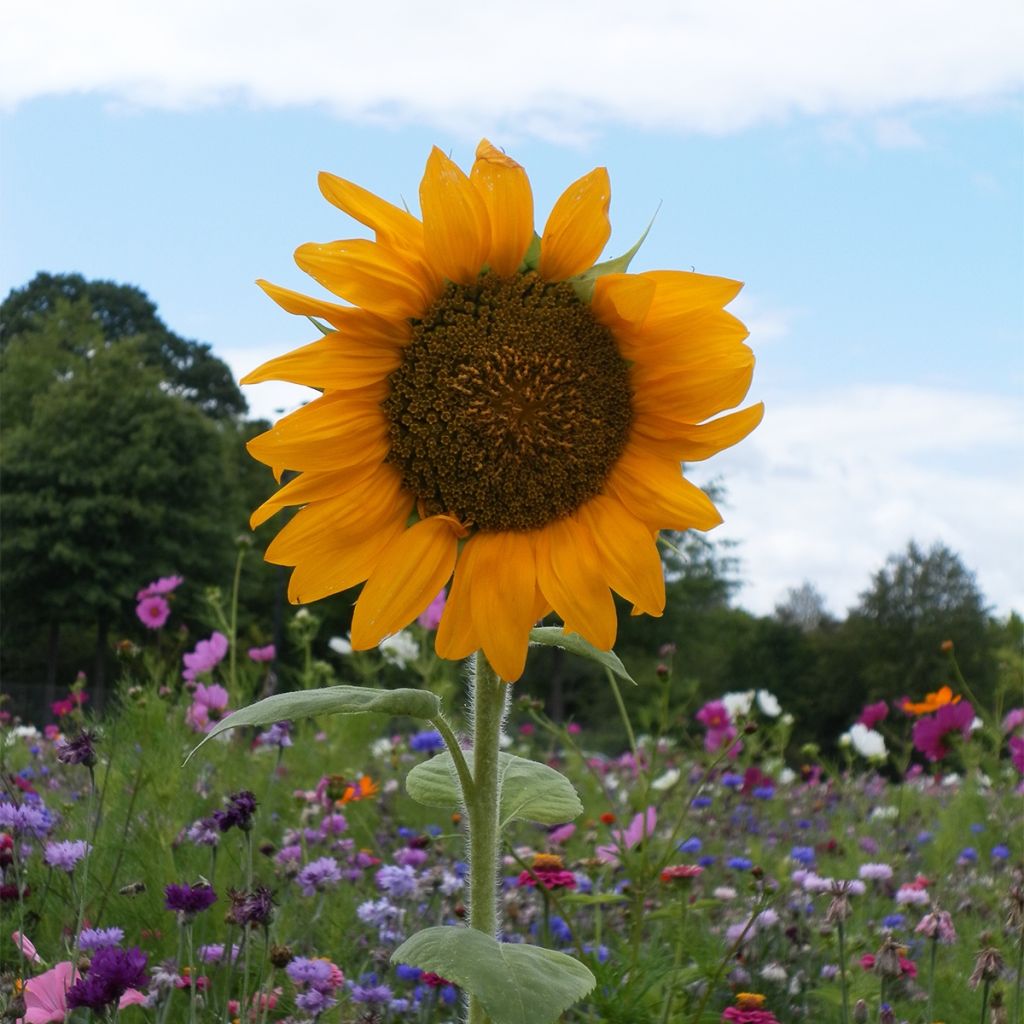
[464,651,508,1024]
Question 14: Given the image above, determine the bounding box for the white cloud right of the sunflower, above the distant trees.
[690,386,1024,614]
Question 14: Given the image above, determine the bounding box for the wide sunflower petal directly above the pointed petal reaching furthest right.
[630,345,754,423]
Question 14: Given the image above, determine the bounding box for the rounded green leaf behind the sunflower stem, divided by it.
[406,751,583,827]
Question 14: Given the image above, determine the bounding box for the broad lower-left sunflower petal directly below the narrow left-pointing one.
[264,465,413,565]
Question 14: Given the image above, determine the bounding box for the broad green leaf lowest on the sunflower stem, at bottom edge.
[391,927,596,1024]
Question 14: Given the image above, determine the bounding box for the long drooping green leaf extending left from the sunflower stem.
[185,686,440,764]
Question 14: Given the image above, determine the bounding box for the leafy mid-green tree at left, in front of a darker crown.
[0,331,239,692]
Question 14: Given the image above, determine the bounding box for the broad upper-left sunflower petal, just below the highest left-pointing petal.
[295,239,435,319]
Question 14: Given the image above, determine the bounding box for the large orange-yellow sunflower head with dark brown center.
[243,140,763,681]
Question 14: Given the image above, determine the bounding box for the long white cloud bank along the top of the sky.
[0,0,1024,136]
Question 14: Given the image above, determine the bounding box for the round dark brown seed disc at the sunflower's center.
[383,273,632,530]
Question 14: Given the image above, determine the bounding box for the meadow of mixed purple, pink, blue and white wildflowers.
[0,587,1024,1024]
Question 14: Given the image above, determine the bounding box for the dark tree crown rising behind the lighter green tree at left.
[0,273,246,419]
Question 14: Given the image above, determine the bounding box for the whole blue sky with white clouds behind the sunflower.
[0,0,1024,615]
